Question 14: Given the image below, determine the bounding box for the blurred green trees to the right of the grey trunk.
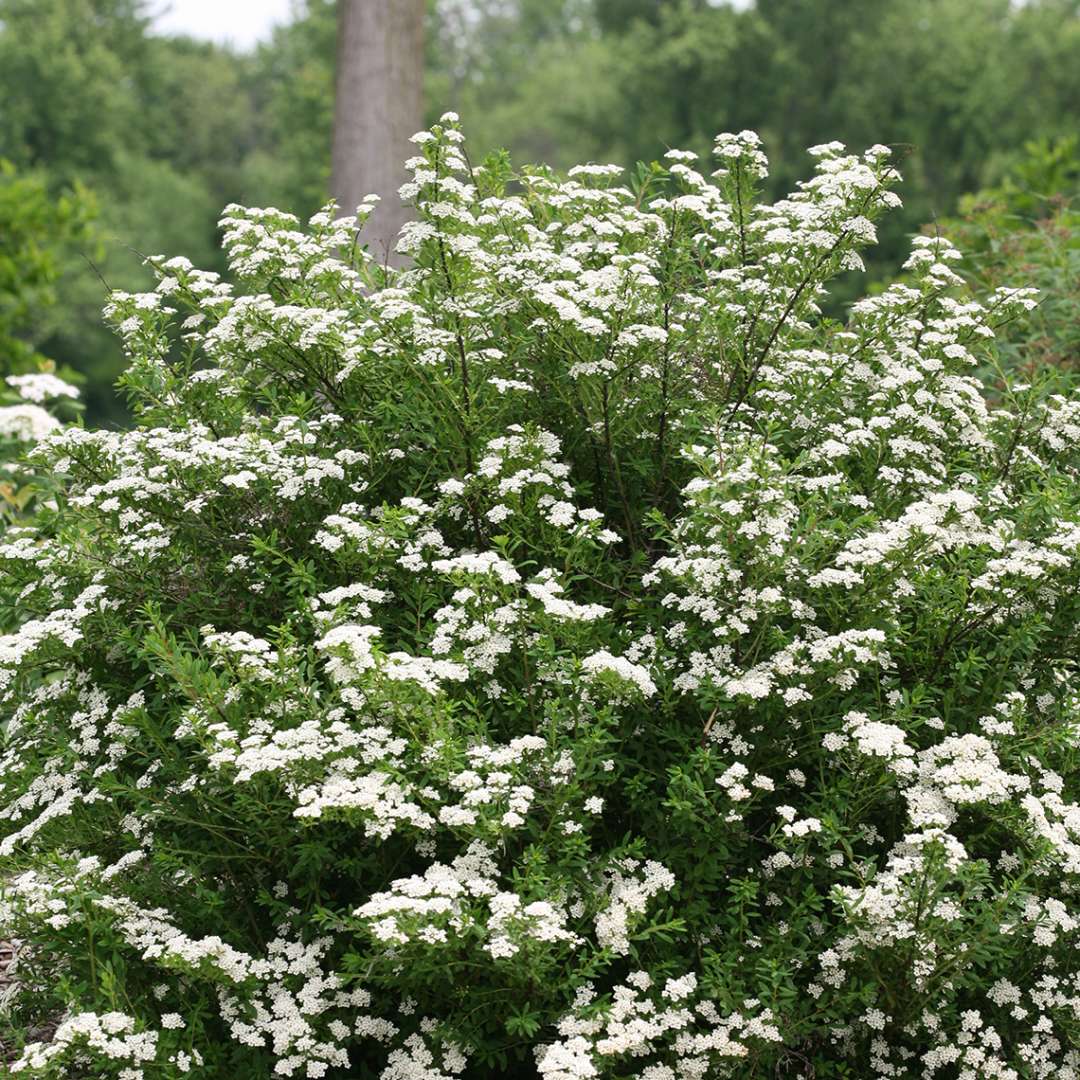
[429,0,1080,293]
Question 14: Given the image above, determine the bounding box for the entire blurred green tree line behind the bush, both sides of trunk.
[0,0,1080,423]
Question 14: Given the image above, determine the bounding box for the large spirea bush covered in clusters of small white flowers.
[0,116,1080,1080]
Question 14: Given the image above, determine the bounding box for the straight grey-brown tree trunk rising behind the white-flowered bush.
[330,0,424,261]
